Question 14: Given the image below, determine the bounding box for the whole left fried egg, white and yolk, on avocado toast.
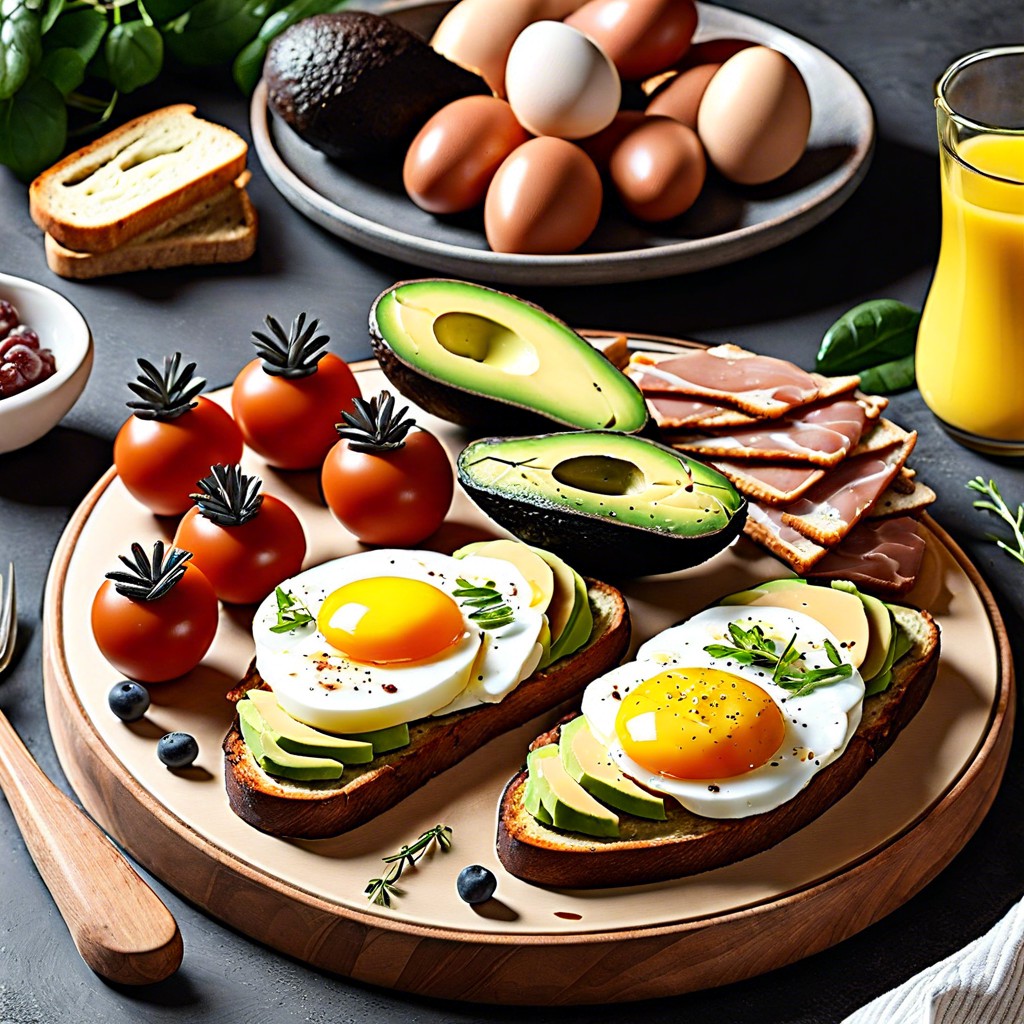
[253,549,544,733]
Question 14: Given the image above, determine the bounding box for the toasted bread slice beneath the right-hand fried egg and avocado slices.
[498,607,939,889]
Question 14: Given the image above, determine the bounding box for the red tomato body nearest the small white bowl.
[114,395,242,515]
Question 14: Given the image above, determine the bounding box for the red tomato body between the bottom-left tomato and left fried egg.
[174,495,306,604]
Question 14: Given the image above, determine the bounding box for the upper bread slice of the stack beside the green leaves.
[29,103,248,253]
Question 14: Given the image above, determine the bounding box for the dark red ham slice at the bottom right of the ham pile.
[808,516,925,594]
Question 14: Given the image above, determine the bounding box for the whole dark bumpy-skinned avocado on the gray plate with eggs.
[263,10,490,161]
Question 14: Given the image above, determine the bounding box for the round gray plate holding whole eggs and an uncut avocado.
[250,3,874,285]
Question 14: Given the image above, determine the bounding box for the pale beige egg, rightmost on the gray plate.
[697,46,811,185]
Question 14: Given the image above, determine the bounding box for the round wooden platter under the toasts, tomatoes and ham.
[44,350,1014,1006]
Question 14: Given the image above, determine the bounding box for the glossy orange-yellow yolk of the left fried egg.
[316,577,465,665]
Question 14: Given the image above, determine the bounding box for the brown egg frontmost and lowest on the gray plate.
[483,135,602,254]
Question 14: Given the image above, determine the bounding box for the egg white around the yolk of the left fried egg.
[253,549,544,733]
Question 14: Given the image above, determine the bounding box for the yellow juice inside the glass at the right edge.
[916,135,1024,441]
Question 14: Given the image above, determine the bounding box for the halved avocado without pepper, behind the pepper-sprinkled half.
[370,280,647,433]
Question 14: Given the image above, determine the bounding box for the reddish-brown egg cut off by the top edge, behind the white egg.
[565,0,697,79]
